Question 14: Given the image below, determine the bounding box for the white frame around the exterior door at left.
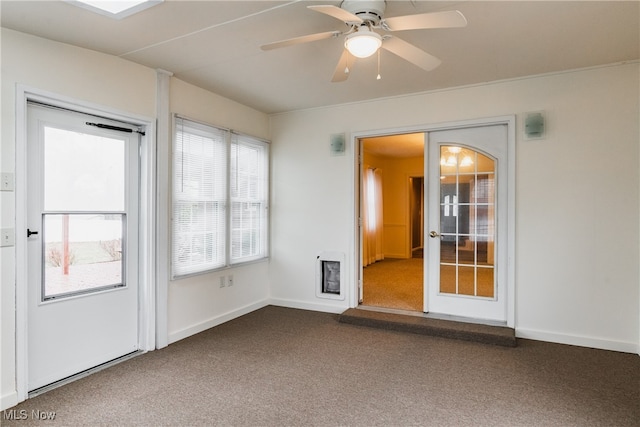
[15,85,157,402]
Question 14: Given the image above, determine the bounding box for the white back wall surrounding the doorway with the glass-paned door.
[270,62,640,352]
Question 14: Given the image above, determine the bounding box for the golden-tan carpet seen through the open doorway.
[362,258,424,312]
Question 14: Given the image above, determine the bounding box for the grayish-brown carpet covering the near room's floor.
[2,307,640,426]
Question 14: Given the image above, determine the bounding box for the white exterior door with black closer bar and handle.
[27,104,140,391]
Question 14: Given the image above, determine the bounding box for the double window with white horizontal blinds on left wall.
[172,117,269,277]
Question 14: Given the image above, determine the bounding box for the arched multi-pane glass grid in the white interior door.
[440,146,495,298]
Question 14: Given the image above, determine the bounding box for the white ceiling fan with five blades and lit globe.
[261,0,467,82]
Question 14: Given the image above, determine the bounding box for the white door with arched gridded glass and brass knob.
[425,125,508,322]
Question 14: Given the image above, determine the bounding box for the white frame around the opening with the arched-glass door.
[349,115,516,328]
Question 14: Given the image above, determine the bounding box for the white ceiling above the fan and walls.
[0,0,640,113]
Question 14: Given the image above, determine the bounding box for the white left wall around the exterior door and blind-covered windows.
[0,29,269,409]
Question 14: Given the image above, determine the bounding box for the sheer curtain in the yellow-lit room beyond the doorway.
[362,167,384,267]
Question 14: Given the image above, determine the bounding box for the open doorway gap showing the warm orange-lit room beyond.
[361,132,424,313]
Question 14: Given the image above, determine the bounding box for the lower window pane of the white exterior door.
[42,214,125,300]
